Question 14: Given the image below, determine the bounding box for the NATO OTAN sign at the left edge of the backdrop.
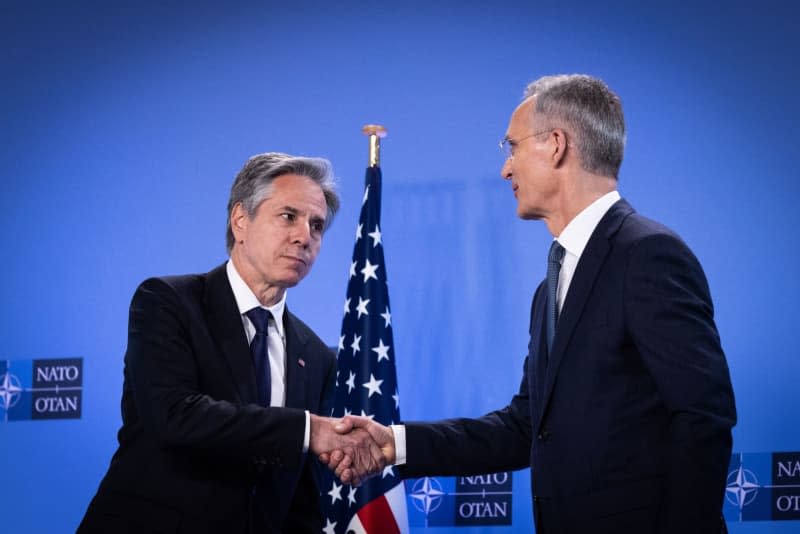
[0,358,83,422]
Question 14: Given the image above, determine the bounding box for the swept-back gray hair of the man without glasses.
[226,152,339,253]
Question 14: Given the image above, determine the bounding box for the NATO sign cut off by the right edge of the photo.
[723,452,800,521]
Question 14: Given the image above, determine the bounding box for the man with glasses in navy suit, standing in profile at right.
[330,75,736,534]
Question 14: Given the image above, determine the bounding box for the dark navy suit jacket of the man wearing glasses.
[403,200,736,534]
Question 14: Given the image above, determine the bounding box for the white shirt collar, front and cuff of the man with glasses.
[391,191,620,465]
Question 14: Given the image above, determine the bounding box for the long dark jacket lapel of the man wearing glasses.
[536,199,633,428]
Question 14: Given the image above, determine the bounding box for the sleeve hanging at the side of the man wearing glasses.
[624,234,736,533]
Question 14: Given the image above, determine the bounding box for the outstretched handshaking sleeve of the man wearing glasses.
[402,358,531,477]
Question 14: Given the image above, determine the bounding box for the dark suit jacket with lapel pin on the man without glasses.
[78,265,336,534]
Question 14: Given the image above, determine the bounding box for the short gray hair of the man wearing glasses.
[523,74,625,178]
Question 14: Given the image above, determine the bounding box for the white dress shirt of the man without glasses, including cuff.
[225,260,311,452]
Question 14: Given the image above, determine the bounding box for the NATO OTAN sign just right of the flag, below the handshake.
[406,472,512,527]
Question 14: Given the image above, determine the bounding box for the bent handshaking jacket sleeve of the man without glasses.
[124,279,305,467]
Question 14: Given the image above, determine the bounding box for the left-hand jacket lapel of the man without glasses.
[205,264,258,403]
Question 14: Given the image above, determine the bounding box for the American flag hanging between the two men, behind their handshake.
[322,167,408,534]
